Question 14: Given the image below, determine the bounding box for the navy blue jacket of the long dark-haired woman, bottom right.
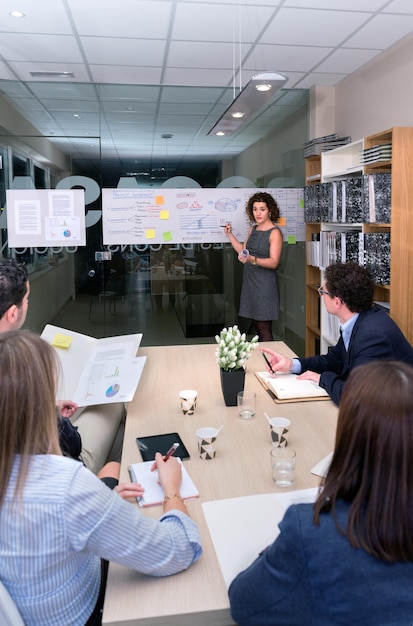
[229,501,413,626]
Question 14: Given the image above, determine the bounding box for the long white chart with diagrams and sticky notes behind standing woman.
[102,188,305,245]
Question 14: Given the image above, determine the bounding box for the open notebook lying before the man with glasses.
[255,372,330,402]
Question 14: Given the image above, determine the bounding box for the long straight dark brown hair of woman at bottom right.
[314,361,413,562]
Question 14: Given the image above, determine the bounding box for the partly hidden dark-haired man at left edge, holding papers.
[0,258,126,474]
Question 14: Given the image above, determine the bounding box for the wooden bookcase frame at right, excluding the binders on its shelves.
[306,127,413,356]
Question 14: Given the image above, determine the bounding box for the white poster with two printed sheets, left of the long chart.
[6,189,86,248]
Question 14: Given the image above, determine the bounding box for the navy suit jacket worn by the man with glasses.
[299,307,413,404]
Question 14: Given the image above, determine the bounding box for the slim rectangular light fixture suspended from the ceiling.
[207,72,287,137]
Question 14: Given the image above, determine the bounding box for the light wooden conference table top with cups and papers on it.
[103,342,337,626]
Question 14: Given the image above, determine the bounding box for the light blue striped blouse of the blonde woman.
[0,455,202,626]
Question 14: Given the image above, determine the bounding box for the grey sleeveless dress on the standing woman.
[239,226,280,321]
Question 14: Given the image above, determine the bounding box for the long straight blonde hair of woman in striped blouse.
[0,330,61,504]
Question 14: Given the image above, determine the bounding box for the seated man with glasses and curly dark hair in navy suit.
[261,262,413,404]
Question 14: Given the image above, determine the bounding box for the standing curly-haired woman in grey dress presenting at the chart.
[224,192,283,341]
